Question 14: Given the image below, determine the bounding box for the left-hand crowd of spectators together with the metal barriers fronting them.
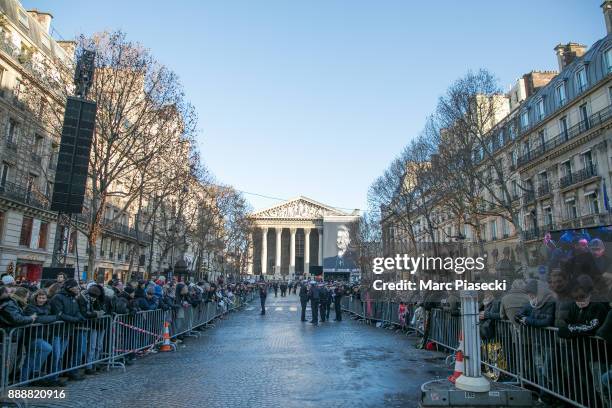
[0,275,254,393]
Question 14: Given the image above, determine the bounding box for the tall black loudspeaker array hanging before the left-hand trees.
[51,97,96,214]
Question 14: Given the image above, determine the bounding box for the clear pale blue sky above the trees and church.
[23,0,605,214]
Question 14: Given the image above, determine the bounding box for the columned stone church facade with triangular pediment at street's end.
[249,197,359,280]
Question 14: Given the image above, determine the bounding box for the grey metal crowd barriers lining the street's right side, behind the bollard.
[342,295,612,408]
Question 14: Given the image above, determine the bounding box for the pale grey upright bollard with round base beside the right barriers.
[455,290,491,392]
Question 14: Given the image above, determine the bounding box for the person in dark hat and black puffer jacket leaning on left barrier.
[50,279,87,380]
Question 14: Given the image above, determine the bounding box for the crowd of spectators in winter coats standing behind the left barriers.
[0,273,253,386]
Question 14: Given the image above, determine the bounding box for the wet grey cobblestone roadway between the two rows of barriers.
[29,295,449,408]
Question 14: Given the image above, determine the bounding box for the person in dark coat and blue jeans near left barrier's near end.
[21,289,57,387]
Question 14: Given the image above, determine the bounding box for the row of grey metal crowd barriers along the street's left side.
[0,292,254,391]
